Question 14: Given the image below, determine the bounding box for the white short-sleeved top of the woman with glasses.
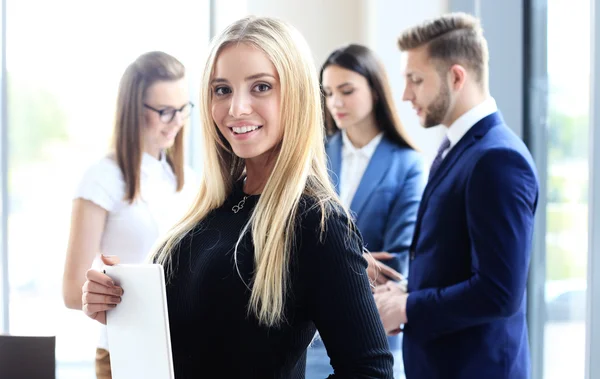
[74,153,198,350]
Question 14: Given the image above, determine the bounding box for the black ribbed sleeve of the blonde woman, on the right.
[300,207,393,379]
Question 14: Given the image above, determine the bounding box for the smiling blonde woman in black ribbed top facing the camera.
[84,17,393,379]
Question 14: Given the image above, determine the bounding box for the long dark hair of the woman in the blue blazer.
[319,44,416,150]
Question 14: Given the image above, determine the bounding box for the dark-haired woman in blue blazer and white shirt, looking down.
[306,44,426,378]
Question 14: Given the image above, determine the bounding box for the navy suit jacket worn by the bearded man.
[403,112,538,379]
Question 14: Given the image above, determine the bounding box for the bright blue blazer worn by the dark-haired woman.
[326,133,426,275]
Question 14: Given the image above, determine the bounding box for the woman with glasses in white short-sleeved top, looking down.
[63,52,196,379]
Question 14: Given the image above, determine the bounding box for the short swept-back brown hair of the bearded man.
[398,12,489,86]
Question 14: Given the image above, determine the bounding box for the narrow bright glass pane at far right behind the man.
[544,0,590,379]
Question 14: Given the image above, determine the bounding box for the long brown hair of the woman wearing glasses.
[113,51,185,203]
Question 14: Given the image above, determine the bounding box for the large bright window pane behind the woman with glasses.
[7,0,210,379]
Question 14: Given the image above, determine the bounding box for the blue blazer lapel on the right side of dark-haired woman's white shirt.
[350,137,394,215]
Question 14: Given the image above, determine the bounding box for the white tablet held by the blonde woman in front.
[104,264,175,379]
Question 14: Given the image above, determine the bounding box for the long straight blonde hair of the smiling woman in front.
[153,17,339,326]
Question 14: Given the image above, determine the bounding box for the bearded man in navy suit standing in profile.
[375,13,538,379]
